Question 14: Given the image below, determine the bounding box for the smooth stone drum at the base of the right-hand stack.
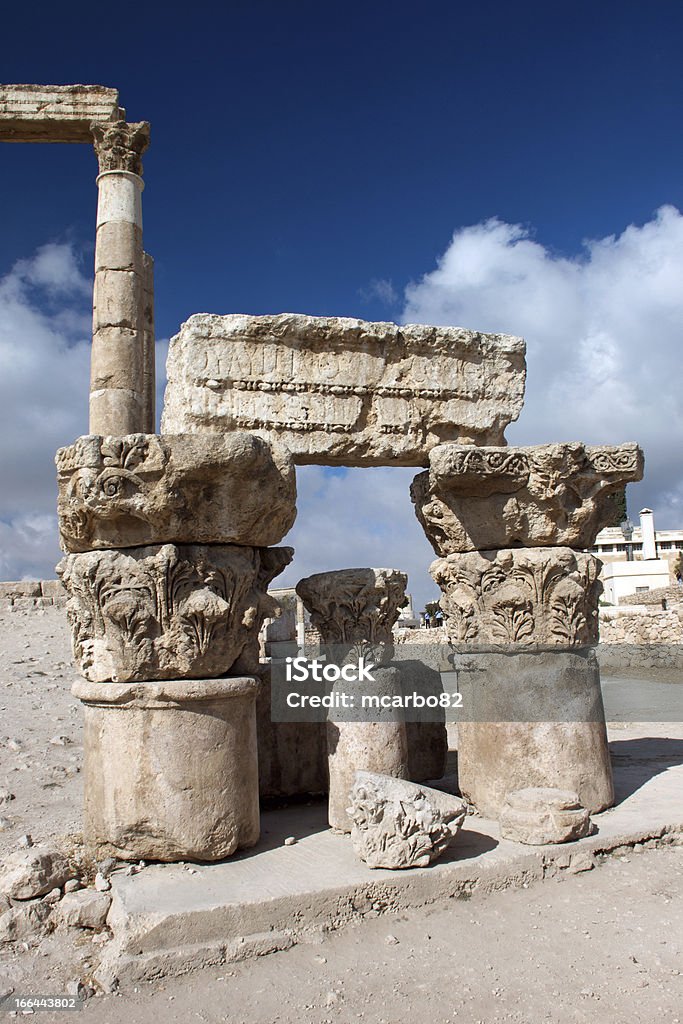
[454,645,614,818]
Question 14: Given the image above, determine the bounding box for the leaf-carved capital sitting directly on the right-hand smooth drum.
[429,548,602,647]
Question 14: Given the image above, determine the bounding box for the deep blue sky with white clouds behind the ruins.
[0,0,683,595]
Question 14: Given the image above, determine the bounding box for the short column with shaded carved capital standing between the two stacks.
[296,568,409,833]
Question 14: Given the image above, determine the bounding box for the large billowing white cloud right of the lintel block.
[401,206,683,527]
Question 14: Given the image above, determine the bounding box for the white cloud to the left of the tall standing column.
[0,243,91,579]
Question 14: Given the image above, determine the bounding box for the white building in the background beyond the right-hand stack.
[590,509,683,604]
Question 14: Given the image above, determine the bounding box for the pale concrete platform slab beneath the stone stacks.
[96,723,683,989]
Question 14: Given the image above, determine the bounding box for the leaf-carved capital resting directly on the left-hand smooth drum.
[57,544,293,682]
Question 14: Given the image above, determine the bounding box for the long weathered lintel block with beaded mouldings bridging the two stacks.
[162,313,525,466]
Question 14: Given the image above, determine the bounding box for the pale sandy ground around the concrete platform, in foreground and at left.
[0,608,683,1024]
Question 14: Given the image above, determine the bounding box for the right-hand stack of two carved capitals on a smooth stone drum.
[412,443,643,817]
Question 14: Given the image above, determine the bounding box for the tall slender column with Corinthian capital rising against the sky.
[90,121,155,435]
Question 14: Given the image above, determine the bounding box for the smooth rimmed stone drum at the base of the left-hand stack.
[72,678,259,861]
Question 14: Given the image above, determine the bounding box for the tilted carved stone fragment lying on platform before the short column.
[348,771,467,868]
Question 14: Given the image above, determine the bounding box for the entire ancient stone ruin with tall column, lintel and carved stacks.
[0,79,643,867]
